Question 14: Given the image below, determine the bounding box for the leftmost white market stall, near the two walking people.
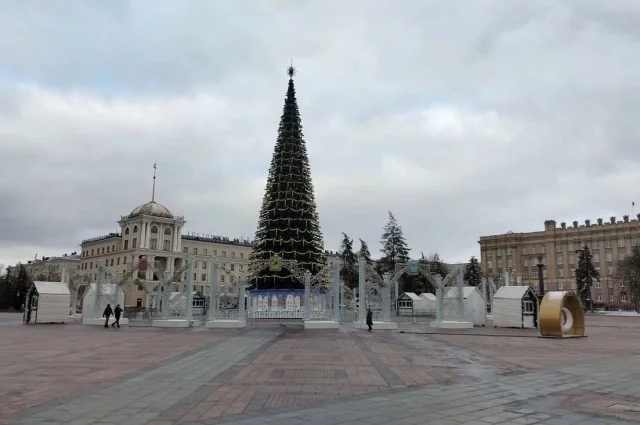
[23,281,73,323]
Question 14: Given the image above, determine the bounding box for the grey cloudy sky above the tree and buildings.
[0,0,640,264]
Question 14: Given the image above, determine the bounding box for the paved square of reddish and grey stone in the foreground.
[0,314,640,425]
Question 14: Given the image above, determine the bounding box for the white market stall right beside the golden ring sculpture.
[492,286,538,328]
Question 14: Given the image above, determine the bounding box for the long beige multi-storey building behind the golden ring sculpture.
[478,214,640,307]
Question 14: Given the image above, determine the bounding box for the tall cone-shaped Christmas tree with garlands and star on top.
[251,67,325,289]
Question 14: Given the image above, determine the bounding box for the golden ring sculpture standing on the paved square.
[540,291,585,338]
